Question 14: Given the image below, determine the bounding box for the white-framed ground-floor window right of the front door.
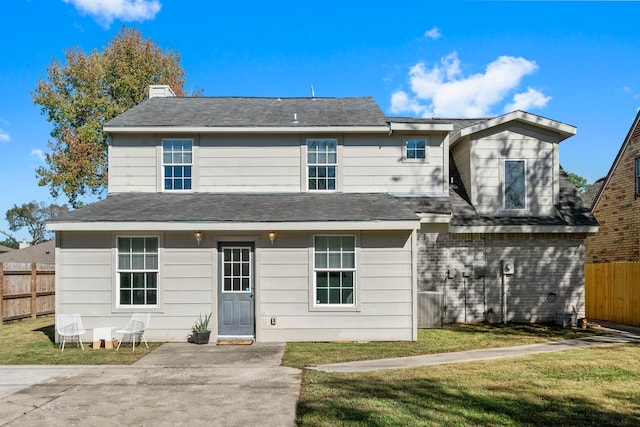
[313,235,356,307]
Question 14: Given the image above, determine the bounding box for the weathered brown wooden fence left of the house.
[0,262,56,324]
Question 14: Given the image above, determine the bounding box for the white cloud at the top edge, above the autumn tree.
[62,0,162,28]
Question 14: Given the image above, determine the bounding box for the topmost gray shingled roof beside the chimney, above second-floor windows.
[105,97,386,127]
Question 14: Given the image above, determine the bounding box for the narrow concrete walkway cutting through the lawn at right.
[309,324,640,372]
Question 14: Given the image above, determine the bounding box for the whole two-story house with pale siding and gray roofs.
[49,86,597,341]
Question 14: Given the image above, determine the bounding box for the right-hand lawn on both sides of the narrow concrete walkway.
[283,325,640,427]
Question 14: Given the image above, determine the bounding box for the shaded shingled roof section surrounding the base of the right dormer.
[449,168,598,227]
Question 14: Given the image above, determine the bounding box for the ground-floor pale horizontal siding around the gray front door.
[56,232,412,341]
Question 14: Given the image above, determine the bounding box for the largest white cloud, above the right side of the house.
[391,52,550,117]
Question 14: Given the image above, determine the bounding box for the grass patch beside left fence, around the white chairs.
[0,317,160,365]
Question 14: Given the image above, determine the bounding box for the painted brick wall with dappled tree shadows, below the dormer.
[418,234,584,322]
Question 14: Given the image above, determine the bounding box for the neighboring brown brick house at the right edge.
[585,112,640,263]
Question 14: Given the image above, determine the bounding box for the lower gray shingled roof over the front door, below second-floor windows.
[51,193,418,223]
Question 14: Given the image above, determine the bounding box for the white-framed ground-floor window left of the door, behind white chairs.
[116,236,159,307]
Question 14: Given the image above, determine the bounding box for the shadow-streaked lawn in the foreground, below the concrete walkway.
[298,344,640,426]
